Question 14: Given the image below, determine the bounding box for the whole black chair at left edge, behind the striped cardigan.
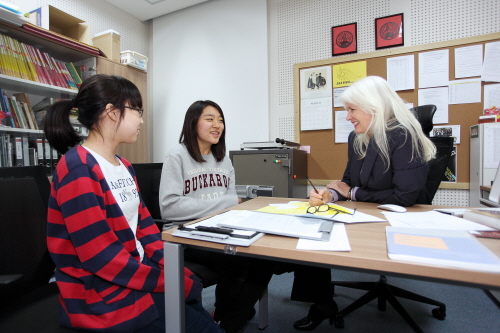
[0,166,81,333]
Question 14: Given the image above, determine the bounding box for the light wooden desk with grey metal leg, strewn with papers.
[162,197,500,332]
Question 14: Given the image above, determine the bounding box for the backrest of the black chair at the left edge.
[0,166,55,304]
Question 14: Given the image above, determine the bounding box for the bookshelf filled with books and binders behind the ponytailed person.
[0,21,92,170]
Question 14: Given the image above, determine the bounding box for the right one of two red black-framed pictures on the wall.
[375,13,404,50]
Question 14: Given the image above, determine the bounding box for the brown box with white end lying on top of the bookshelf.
[29,5,90,45]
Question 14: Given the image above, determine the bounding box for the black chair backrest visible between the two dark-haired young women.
[132,163,163,220]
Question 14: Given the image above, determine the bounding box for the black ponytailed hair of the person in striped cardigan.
[43,74,142,154]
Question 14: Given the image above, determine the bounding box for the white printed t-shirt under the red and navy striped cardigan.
[83,146,144,261]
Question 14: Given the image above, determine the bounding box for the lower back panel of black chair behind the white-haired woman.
[425,137,453,204]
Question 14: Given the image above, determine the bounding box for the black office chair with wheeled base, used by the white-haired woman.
[332,105,453,332]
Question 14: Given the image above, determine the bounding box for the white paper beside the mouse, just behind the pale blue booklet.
[382,211,495,231]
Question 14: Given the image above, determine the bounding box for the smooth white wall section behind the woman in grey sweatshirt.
[150,0,269,162]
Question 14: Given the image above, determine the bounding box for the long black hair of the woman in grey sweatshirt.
[179,100,226,163]
